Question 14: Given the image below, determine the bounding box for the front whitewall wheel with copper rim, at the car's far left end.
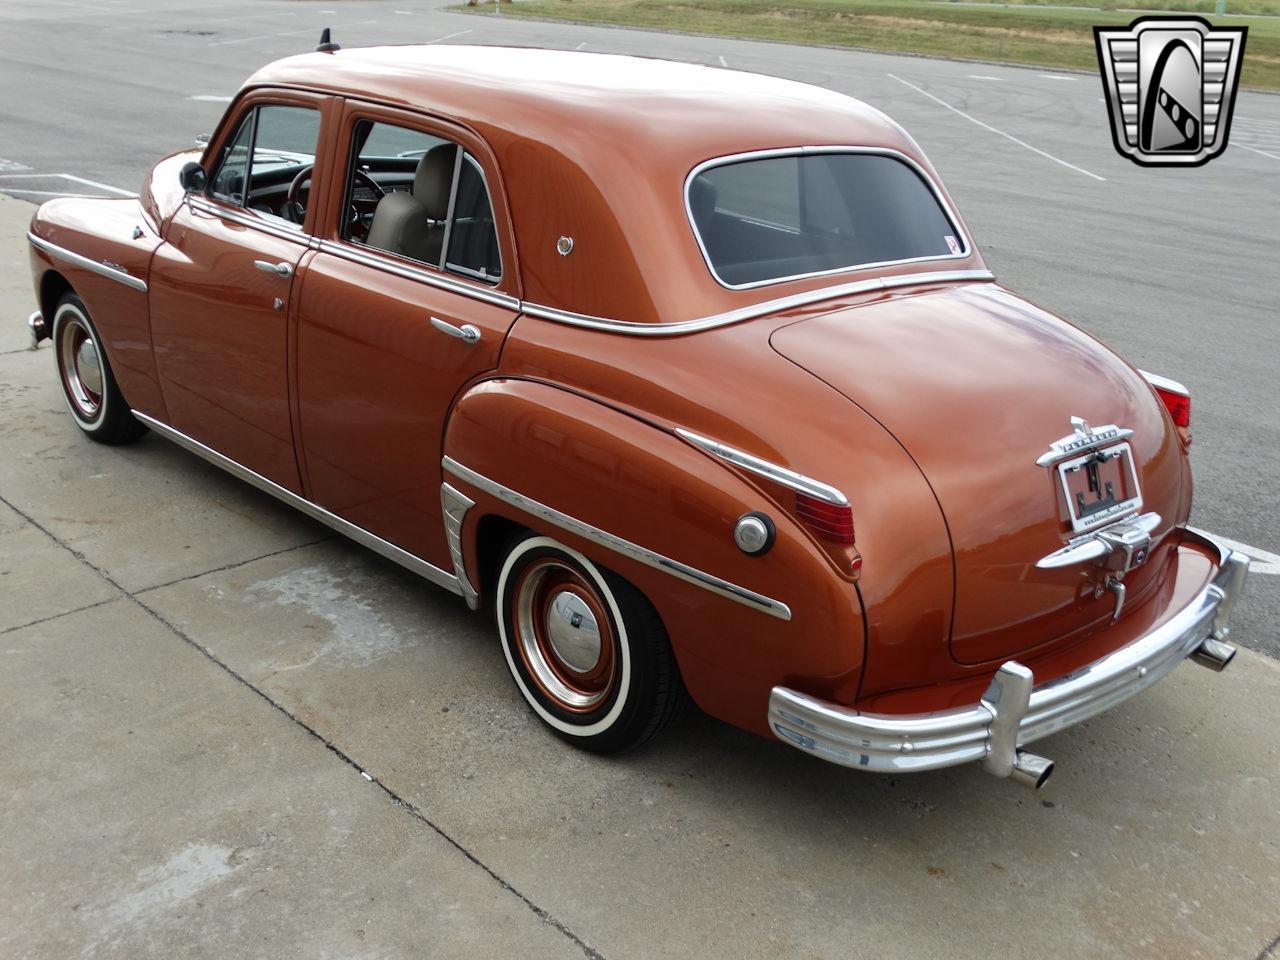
[52,293,147,444]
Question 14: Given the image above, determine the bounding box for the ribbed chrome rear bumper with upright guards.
[769,531,1249,787]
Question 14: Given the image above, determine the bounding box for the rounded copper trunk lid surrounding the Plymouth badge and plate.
[771,284,1181,664]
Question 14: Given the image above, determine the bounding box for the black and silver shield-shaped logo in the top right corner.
[1093,17,1248,166]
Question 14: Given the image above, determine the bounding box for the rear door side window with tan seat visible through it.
[342,120,502,283]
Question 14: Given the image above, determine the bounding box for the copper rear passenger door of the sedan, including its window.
[297,105,518,570]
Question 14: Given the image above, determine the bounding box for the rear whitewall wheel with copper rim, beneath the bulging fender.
[495,532,689,753]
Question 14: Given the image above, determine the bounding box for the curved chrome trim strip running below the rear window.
[521,270,996,337]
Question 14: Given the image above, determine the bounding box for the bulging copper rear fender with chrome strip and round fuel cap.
[444,379,865,733]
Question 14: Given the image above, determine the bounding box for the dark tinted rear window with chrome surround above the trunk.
[689,152,968,287]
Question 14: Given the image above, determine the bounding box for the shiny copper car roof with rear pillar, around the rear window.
[246,45,980,323]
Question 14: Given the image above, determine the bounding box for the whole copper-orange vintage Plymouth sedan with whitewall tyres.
[29,45,1247,786]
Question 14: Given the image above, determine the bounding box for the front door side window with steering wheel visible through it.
[210,104,320,225]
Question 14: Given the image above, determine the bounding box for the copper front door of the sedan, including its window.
[150,95,325,494]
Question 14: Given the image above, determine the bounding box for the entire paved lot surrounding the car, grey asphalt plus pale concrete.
[0,0,1280,960]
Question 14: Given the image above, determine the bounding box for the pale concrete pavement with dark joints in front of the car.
[0,198,1280,960]
